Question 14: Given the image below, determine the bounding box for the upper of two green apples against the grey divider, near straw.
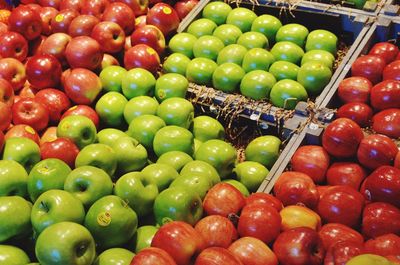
[245,135,282,168]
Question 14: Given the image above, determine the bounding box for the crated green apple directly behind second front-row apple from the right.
[242,48,275,73]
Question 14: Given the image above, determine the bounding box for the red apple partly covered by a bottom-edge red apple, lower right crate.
[318,223,364,250]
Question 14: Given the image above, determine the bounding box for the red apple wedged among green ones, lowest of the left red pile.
[40,137,79,168]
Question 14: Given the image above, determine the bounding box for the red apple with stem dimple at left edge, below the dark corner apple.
[0,31,28,62]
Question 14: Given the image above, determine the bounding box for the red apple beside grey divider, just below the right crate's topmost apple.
[351,55,386,84]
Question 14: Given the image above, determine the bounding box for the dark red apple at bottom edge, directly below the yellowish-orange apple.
[273,227,325,265]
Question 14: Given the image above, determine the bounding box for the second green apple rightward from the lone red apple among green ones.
[113,136,147,174]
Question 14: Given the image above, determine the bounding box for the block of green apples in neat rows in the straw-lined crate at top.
[164,1,338,109]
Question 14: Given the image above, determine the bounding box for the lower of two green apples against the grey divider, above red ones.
[233,161,269,192]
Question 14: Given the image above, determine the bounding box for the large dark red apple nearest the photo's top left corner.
[8,5,42,40]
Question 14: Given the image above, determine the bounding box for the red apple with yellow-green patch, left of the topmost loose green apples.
[63,67,102,105]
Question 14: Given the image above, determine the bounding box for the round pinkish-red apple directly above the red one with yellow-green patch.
[65,36,103,70]
